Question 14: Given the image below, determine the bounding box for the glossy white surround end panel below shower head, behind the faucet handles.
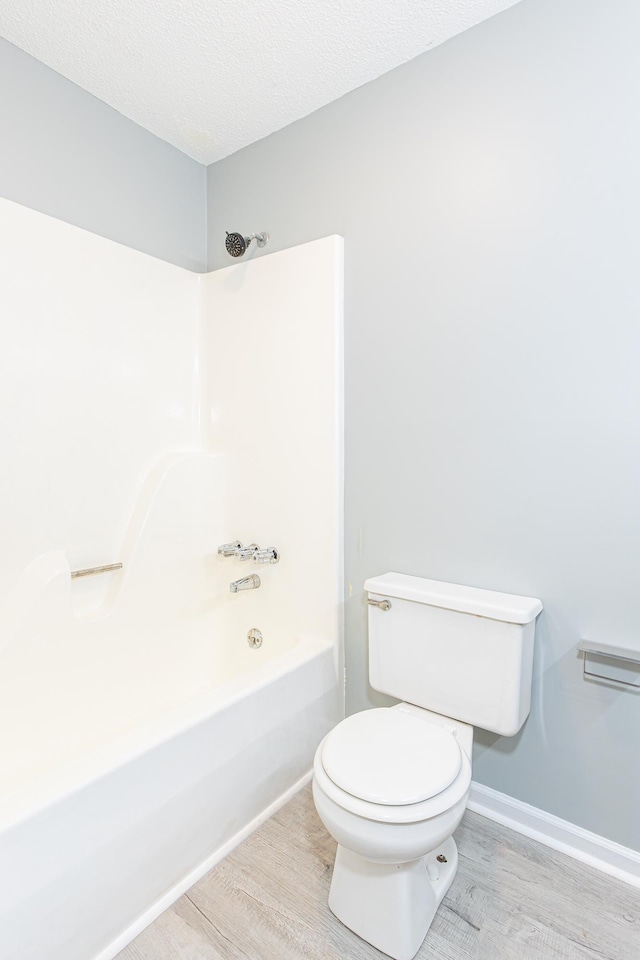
[201,238,343,656]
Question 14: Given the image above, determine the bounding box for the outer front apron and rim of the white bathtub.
[0,639,341,960]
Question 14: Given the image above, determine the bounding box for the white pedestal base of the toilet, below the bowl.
[329,837,458,960]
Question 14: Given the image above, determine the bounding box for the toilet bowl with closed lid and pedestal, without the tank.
[313,704,471,960]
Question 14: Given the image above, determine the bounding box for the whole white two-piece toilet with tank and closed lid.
[313,573,542,960]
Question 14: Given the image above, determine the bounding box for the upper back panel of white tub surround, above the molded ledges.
[0,199,199,605]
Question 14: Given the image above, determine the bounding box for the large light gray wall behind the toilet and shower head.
[208,0,640,849]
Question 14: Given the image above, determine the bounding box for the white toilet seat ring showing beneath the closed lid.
[313,707,471,823]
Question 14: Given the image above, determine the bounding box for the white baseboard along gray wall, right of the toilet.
[468,780,640,887]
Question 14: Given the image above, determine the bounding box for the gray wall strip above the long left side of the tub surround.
[0,39,206,270]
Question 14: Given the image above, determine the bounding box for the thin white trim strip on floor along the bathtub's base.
[93,770,313,960]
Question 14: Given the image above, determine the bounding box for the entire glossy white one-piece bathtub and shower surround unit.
[0,202,343,960]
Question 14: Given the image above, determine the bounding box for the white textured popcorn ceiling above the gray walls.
[0,0,517,163]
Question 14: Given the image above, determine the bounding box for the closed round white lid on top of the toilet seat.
[322,707,462,806]
